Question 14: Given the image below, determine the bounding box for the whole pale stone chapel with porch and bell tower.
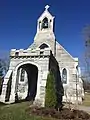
[0,5,84,106]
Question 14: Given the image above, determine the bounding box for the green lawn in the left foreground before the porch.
[0,102,56,120]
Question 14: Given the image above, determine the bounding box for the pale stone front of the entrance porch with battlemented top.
[0,48,50,106]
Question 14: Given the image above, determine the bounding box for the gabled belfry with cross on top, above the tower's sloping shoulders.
[37,5,54,32]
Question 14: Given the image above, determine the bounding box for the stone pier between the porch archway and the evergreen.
[34,58,49,107]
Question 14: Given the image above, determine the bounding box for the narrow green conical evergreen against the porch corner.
[45,71,57,108]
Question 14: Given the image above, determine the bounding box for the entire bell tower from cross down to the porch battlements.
[29,5,56,55]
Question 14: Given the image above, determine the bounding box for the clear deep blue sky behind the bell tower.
[0,0,90,57]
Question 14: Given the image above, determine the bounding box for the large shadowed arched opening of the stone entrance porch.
[15,63,38,100]
